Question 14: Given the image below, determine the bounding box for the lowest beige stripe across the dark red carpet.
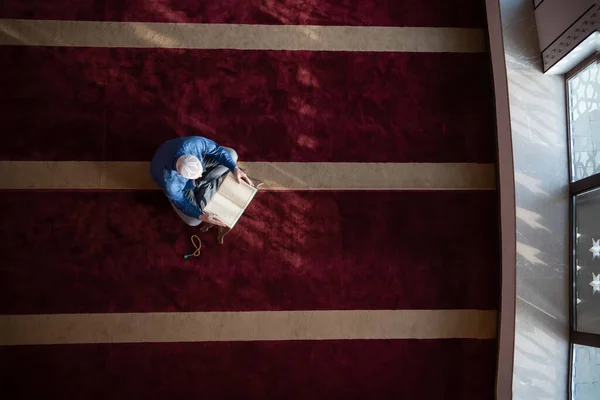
[0,310,496,346]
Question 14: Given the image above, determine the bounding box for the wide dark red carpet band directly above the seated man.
[0,47,495,162]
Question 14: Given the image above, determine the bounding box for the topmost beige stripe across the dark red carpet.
[0,19,486,53]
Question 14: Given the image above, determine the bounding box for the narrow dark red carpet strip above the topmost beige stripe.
[0,0,485,27]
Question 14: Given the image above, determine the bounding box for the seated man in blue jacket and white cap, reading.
[150,136,252,226]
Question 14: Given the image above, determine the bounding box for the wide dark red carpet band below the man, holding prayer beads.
[0,191,498,314]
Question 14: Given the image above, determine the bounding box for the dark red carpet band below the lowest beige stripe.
[0,339,496,400]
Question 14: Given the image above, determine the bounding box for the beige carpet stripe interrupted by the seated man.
[0,161,495,190]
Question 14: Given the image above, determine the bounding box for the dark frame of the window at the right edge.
[565,53,600,400]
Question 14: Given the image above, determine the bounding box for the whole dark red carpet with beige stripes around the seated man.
[0,0,499,400]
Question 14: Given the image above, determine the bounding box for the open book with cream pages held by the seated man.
[204,174,258,229]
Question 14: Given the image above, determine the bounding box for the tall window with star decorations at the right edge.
[566,55,600,400]
